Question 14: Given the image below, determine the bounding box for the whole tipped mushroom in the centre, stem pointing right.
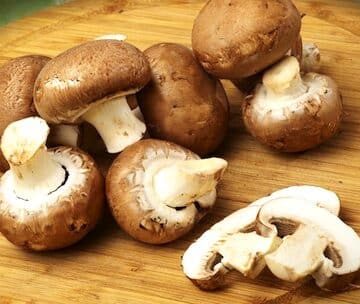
[106,139,227,244]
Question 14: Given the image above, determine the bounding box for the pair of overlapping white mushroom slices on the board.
[182,186,360,291]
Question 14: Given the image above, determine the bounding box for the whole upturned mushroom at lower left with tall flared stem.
[0,117,104,251]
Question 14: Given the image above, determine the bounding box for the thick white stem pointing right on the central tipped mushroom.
[153,157,227,208]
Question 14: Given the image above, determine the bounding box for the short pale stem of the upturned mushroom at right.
[263,56,308,100]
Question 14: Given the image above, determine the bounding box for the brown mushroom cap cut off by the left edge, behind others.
[0,55,50,171]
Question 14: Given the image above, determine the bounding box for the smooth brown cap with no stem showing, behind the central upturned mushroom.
[137,43,229,155]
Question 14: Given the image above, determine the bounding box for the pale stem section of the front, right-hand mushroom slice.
[265,225,328,282]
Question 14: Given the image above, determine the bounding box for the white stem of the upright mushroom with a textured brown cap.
[82,96,146,153]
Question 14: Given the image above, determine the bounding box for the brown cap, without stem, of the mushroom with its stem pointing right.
[106,139,216,244]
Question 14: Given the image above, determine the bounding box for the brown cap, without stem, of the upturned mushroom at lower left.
[0,147,104,251]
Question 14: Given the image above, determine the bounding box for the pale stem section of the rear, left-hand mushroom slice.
[219,232,281,278]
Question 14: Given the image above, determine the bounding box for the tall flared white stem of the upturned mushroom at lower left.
[1,117,66,200]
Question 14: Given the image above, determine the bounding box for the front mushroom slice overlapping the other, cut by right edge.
[256,198,360,290]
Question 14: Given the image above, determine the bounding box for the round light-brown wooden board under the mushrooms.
[0,0,360,304]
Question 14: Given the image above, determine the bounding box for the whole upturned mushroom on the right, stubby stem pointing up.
[242,57,343,152]
